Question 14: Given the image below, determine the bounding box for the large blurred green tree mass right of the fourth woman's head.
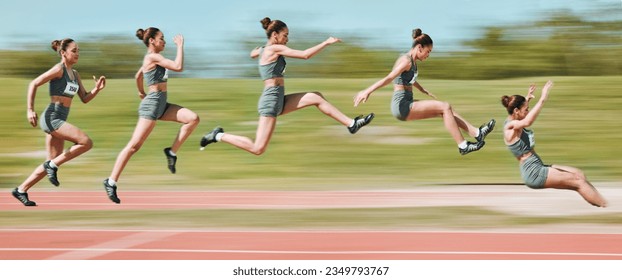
[425,8,622,79]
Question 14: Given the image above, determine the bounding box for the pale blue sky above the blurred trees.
[0,0,622,75]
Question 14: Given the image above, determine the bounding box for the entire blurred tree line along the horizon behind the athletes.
[0,7,622,79]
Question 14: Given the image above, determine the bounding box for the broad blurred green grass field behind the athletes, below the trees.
[0,75,622,190]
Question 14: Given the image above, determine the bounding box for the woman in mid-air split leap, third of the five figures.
[200,17,374,155]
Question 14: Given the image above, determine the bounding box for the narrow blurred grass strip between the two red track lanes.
[0,206,622,230]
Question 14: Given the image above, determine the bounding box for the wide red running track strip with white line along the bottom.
[0,229,622,260]
